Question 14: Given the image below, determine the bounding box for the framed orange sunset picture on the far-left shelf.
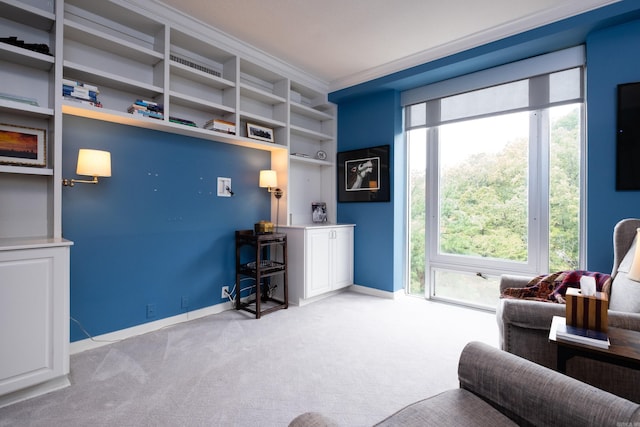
[0,124,47,167]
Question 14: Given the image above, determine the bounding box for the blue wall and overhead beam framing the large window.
[329,0,640,291]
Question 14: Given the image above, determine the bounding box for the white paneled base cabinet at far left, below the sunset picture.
[0,239,71,407]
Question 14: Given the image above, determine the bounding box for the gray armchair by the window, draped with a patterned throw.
[496,219,640,402]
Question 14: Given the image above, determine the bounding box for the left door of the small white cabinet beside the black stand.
[305,230,333,298]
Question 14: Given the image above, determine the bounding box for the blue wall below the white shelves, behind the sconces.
[62,116,271,341]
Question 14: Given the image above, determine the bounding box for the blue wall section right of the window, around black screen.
[587,20,640,271]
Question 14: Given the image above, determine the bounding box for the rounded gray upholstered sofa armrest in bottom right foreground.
[458,342,640,427]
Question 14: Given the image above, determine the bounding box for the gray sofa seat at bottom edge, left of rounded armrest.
[376,389,517,427]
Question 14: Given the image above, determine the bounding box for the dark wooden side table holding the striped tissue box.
[549,316,640,373]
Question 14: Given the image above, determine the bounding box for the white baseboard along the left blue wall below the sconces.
[69,302,233,354]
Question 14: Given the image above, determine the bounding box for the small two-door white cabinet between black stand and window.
[280,224,354,304]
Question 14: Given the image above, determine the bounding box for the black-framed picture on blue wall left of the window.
[337,145,391,202]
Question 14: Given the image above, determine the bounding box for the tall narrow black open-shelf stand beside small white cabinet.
[235,230,289,319]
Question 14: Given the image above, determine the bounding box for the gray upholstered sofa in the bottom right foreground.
[289,342,640,427]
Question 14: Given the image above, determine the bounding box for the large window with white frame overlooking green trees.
[405,47,583,307]
